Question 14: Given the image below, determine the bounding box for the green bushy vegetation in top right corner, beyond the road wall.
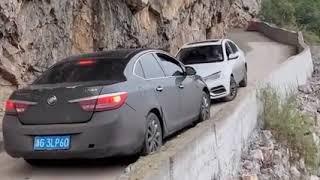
[260,0,320,44]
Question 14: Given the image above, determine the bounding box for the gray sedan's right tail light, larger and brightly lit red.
[69,92,128,111]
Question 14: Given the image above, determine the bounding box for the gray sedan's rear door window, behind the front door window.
[140,54,165,79]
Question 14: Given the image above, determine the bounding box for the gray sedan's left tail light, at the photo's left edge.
[5,100,37,114]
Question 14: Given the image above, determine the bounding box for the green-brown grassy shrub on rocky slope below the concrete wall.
[259,87,319,170]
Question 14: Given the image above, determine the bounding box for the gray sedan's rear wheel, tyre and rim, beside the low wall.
[143,113,162,155]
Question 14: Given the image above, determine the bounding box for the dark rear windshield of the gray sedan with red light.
[33,59,127,84]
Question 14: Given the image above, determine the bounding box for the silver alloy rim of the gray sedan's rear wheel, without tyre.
[147,118,161,152]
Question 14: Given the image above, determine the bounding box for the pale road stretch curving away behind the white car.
[228,30,295,85]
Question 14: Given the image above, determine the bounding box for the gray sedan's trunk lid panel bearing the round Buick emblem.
[12,82,102,125]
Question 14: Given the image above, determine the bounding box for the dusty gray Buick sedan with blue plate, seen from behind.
[3,49,210,164]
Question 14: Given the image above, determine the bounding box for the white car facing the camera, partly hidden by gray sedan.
[177,39,247,101]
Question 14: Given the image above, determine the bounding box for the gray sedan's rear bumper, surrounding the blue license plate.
[3,106,145,159]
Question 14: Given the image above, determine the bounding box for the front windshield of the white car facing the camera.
[177,45,223,64]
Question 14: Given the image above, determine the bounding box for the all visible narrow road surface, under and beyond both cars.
[0,30,294,180]
